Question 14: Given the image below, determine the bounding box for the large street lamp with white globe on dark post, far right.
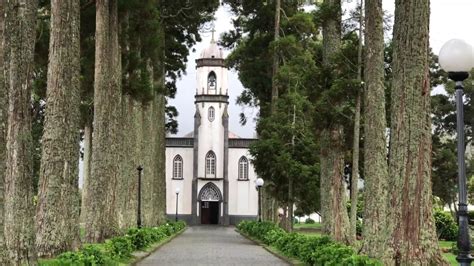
[439,39,474,265]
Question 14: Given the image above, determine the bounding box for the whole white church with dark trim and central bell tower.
[166,39,258,225]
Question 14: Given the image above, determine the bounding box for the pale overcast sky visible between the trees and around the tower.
[169,0,474,138]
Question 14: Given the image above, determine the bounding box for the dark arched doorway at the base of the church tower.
[198,182,222,224]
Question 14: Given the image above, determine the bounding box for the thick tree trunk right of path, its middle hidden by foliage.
[320,0,350,242]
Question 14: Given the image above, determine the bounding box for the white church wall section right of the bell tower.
[229,148,258,215]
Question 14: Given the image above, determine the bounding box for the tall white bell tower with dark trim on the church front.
[192,32,229,225]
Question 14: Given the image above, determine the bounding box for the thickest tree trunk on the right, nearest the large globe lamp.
[386,0,446,265]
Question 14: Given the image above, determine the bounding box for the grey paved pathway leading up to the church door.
[138,226,288,266]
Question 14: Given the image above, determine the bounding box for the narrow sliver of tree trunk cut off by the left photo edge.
[0,1,8,265]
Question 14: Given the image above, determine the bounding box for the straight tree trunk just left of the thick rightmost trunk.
[363,0,391,258]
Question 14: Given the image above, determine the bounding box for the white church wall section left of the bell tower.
[166,147,193,214]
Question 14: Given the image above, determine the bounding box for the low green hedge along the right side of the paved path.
[237,221,382,266]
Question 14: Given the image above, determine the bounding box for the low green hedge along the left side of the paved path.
[40,221,186,266]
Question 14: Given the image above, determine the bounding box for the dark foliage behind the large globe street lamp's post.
[430,68,474,204]
